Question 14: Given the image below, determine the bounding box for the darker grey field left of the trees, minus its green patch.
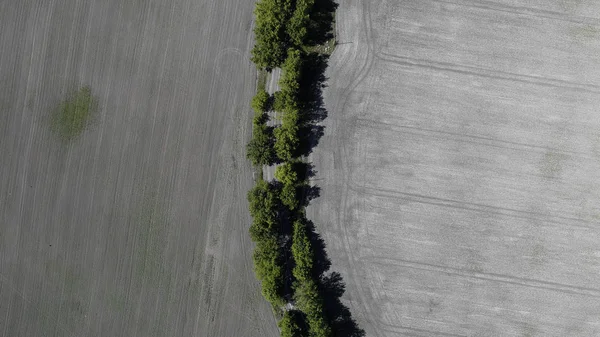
[0,0,278,337]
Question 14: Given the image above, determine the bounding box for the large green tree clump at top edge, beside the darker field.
[251,0,292,69]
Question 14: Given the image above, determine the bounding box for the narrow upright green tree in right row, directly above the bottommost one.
[292,220,314,282]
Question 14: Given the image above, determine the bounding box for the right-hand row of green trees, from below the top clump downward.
[274,43,332,337]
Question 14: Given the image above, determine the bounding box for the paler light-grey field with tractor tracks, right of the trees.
[310,0,600,336]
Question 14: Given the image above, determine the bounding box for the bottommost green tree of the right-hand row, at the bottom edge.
[295,278,331,337]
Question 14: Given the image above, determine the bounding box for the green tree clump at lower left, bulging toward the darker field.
[253,238,284,306]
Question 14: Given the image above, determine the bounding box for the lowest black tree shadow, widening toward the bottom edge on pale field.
[306,220,365,337]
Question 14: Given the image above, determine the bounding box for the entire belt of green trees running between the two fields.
[247,0,340,337]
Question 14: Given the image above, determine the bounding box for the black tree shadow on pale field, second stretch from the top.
[299,53,329,156]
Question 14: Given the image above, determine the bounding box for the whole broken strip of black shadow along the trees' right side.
[298,0,365,337]
